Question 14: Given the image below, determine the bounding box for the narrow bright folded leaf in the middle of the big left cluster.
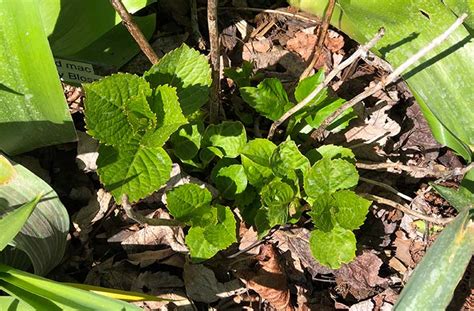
[142,85,188,147]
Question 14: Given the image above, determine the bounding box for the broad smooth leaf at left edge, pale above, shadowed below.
[0,157,69,274]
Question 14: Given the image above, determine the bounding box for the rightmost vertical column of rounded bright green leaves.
[304,150,371,269]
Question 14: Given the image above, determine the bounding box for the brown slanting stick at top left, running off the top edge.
[110,0,159,65]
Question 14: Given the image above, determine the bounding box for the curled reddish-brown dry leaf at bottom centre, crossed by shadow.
[237,244,294,310]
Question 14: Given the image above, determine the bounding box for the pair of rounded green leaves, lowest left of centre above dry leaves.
[166,184,237,262]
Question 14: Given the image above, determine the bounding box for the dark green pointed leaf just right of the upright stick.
[240,78,293,121]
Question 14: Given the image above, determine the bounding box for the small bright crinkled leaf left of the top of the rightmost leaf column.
[270,140,310,177]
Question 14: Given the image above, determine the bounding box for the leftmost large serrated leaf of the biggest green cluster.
[84,73,152,146]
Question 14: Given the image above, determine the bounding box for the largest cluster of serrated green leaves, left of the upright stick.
[84,45,211,202]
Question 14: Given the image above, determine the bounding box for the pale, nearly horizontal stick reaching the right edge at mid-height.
[356,162,474,178]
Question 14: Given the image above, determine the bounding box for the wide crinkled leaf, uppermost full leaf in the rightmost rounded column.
[304,158,359,198]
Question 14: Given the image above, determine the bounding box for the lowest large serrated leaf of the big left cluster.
[97,139,172,202]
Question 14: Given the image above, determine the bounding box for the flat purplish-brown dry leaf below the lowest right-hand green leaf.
[334,251,388,300]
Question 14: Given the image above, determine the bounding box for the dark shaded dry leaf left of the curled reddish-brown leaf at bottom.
[183,263,244,303]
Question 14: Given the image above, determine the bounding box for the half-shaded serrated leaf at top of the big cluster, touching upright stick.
[144,44,212,116]
